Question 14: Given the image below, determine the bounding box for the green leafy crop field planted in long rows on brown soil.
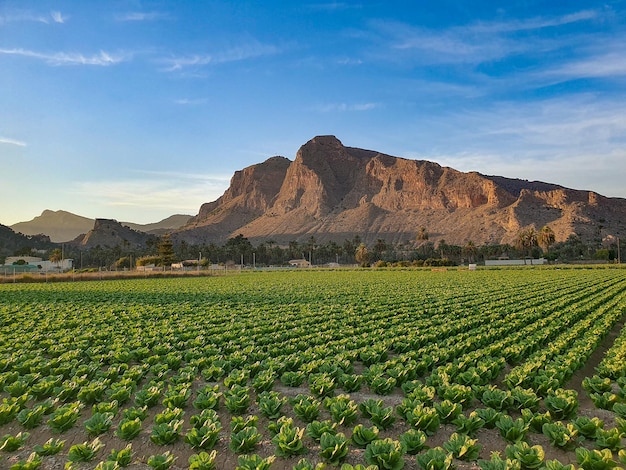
[0,269,626,470]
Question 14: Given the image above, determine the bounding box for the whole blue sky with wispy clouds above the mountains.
[0,0,626,225]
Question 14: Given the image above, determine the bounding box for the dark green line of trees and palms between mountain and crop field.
[14,227,619,269]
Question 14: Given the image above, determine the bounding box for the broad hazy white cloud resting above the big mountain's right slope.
[404,94,626,197]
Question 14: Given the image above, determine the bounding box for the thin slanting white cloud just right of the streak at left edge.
[160,40,280,72]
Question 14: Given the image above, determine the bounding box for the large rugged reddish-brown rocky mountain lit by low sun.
[173,136,626,245]
